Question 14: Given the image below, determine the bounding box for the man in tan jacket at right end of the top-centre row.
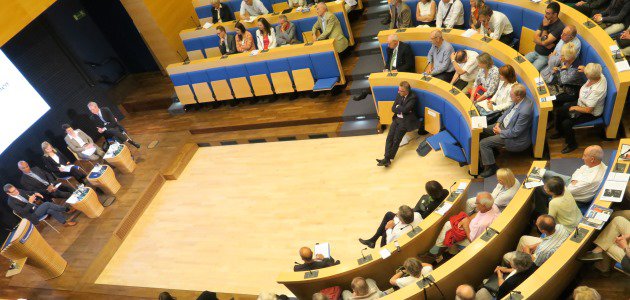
[312,2,348,53]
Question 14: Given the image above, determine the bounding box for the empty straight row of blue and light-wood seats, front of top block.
[166,40,346,105]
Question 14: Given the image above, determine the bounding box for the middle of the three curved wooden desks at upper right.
[378,28,553,158]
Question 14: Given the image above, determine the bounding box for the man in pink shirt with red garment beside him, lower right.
[429,192,501,257]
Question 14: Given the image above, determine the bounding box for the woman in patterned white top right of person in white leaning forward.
[470,52,499,103]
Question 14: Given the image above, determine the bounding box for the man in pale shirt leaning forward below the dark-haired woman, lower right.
[503,215,571,267]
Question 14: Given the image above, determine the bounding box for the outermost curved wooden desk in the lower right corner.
[503,139,630,299]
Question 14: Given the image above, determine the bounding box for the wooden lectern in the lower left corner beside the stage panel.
[0,219,68,280]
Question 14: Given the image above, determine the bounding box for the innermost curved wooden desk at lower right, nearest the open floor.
[276,179,470,299]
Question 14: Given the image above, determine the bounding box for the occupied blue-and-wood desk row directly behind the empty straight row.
[179,2,354,59]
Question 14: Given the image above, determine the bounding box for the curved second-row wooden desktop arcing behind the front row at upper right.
[377,28,553,158]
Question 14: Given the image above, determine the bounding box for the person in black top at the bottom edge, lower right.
[475,251,536,300]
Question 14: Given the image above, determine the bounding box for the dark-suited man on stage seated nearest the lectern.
[4,184,77,226]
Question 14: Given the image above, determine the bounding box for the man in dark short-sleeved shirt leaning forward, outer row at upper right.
[525,2,564,71]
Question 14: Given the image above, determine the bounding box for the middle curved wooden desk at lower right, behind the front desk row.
[382,161,547,299]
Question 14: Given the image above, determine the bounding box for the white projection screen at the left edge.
[0,50,50,154]
